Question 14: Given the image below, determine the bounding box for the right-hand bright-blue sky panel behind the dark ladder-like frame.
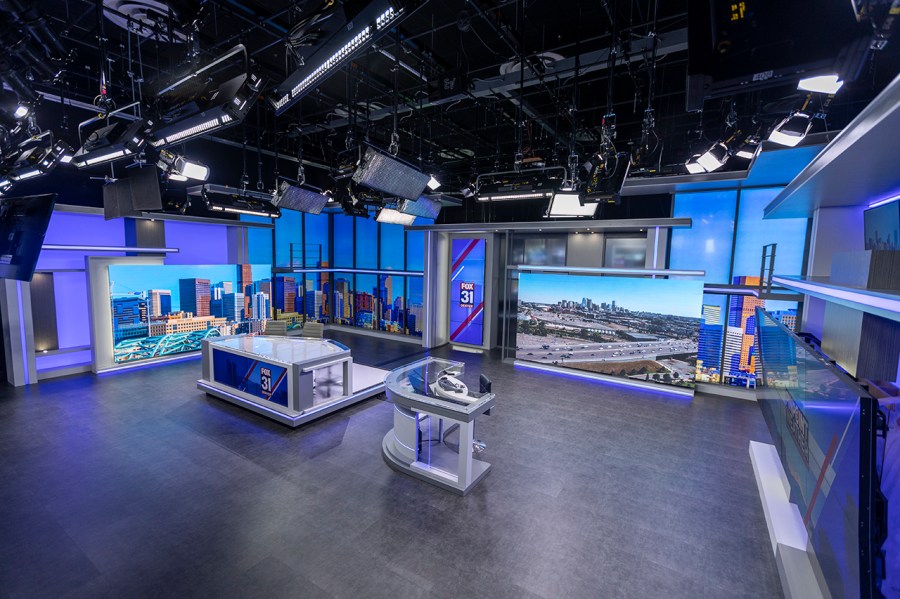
[732,187,807,284]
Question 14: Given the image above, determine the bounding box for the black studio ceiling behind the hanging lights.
[0,0,900,202]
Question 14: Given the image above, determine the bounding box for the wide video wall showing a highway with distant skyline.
[516,273,703,387]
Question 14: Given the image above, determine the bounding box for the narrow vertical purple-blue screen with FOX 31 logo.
[449,239,487,345]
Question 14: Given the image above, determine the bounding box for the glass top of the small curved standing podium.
[384,358,494,415]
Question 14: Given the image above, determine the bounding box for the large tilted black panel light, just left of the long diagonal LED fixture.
[150,44,263,149]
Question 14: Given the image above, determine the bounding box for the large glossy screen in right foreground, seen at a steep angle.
[756,307,875,597]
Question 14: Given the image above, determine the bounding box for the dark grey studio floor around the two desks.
[0,336,781,599]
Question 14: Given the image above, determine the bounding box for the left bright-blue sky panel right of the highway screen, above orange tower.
[669,191,737,283]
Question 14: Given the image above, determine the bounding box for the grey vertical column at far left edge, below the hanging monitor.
[0,279,37,387]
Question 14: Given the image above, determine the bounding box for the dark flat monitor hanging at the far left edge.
[0,193,56,281]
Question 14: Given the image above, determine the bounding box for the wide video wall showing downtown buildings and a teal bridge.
[109,264,273,364]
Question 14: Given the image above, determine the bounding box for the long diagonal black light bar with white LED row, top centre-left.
[269,2,408,115]
